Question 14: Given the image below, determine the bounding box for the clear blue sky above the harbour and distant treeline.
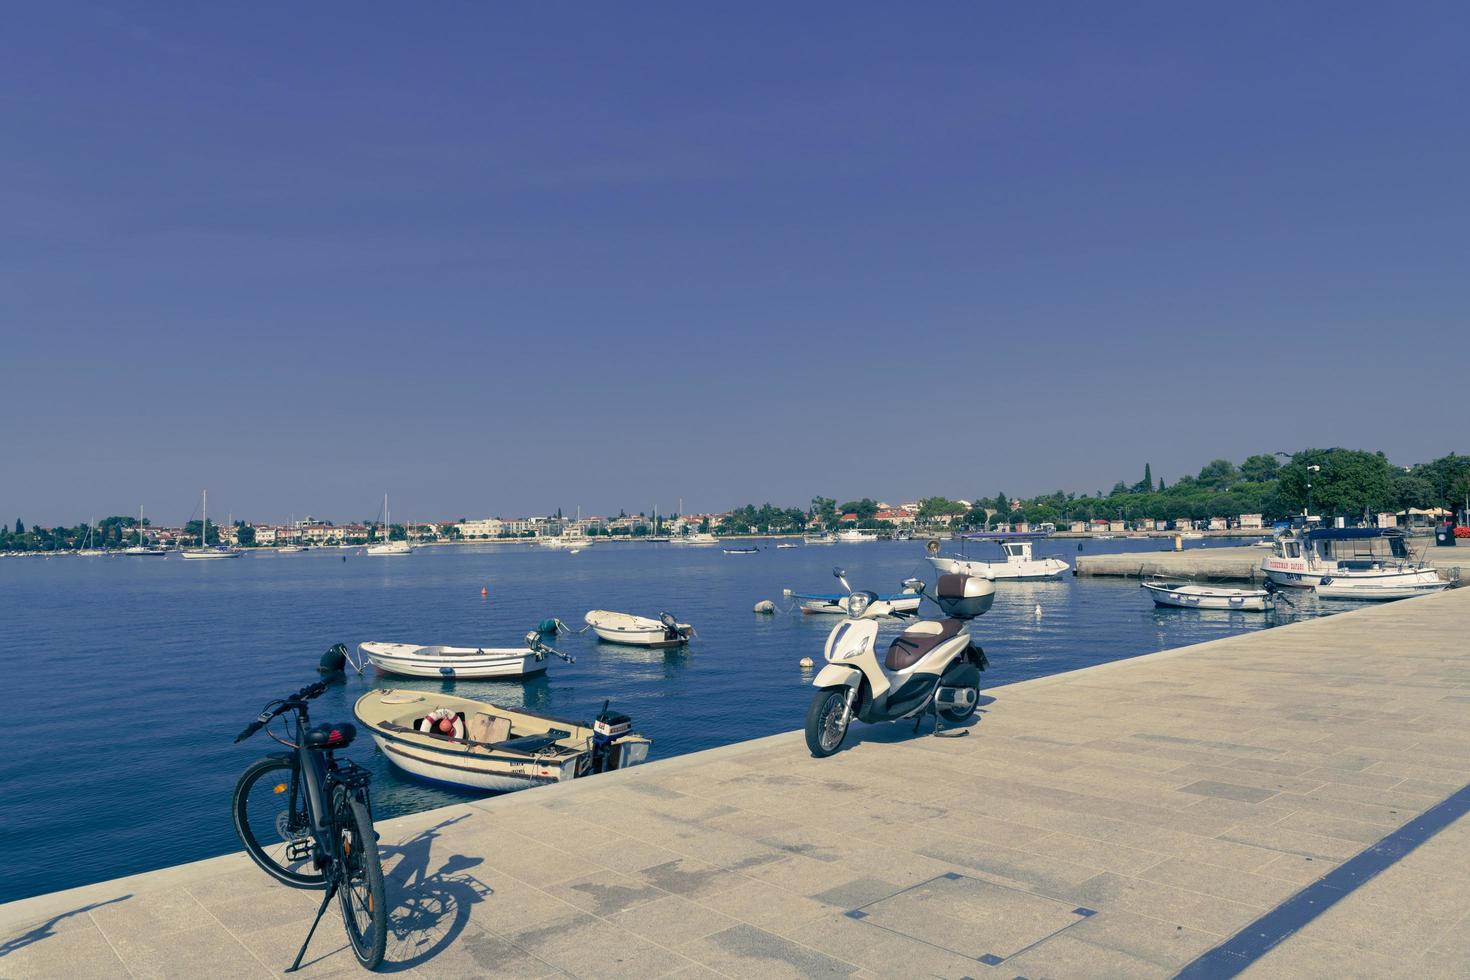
[0,3,1470,523]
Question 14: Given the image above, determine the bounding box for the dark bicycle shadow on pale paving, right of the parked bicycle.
[378,814,494,973]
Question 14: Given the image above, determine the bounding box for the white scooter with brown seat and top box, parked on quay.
[807,569,995,758]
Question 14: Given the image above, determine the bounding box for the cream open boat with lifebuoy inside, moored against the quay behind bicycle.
[353,689,653,792]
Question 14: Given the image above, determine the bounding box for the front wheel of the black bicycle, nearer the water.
[232,758,326,887]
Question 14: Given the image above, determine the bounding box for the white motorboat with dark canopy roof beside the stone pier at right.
[1261,527,1441,589]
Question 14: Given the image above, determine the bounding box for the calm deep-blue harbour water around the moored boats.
[0,539,1334,901]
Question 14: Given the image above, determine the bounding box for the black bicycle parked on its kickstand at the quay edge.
[232,682,388,973]
